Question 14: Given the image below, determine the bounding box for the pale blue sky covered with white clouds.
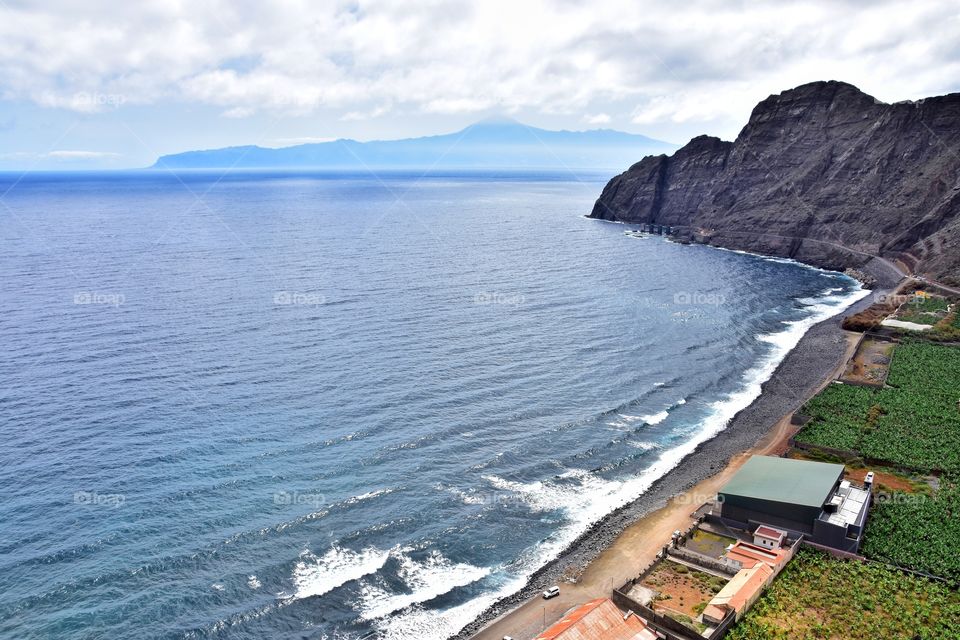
[0,0,960,170]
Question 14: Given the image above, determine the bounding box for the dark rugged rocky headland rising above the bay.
[591,82,960,282]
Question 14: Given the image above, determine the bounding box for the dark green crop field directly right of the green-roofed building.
[863,481,960,584]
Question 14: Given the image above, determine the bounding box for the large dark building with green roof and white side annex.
[717,456,870,551]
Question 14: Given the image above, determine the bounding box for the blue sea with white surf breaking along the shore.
[0,173,865,640]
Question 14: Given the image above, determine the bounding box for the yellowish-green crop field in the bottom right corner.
[727,548,960,640]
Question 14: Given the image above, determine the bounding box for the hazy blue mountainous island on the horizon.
[153,120,677,169]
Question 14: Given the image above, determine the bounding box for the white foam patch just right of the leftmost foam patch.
[358,550,490,620]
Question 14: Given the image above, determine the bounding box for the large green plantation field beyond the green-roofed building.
[797,341,960,471]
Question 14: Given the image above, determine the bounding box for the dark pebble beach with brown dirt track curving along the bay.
[451,276,887,640]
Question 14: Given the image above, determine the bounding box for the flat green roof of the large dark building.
[718,456,843,508]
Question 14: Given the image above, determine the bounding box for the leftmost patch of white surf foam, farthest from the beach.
[280,546,390,600]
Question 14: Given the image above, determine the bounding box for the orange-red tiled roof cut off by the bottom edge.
[535,598,657,640]
